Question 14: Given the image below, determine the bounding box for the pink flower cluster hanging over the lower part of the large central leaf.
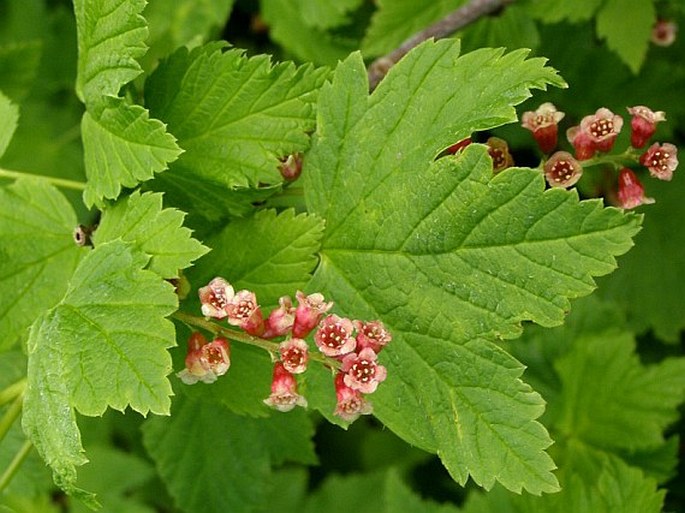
[177,277,392,422]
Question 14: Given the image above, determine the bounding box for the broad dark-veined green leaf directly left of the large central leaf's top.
[145,43,327,188]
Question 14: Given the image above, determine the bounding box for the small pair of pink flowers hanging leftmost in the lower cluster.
[176,333,231,385]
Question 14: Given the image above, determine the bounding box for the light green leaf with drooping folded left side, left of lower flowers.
[22,240,176,503]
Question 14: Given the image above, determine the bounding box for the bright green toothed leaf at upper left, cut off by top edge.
[74,0,148,105]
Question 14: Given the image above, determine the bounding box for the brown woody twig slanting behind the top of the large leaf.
[369,0,514,91]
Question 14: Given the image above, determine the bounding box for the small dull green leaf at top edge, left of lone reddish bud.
[597,0,656,73]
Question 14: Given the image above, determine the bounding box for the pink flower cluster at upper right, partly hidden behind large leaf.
[446,103,678,209]
